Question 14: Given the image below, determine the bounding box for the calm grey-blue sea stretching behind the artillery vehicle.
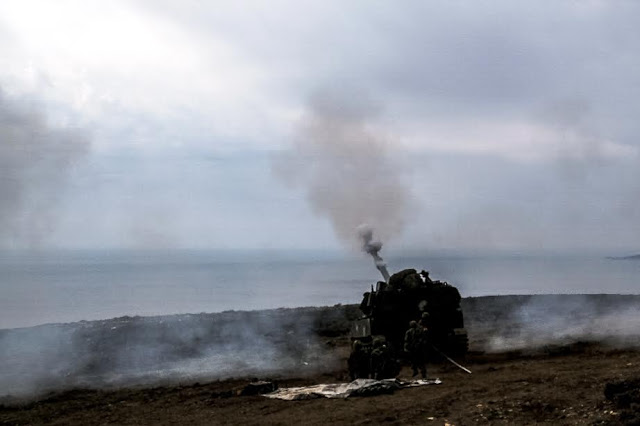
[0,250,640,329]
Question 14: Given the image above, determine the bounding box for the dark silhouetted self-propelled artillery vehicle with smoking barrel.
[350,269,469,375]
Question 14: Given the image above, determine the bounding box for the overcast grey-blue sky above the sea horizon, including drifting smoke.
[0,0,640,253]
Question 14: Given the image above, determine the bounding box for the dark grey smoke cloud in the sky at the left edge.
[0,89,89,247]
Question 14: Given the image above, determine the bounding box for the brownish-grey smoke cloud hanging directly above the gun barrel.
[275,92,410,248]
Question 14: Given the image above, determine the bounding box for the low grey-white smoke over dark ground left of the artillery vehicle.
[0,308,345,398]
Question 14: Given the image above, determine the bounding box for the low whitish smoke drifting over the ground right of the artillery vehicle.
[462,294,640,352]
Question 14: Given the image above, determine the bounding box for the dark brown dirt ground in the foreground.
[0,296,640,425]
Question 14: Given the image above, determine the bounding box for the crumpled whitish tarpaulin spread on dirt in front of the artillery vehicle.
[263,379,442,401]
